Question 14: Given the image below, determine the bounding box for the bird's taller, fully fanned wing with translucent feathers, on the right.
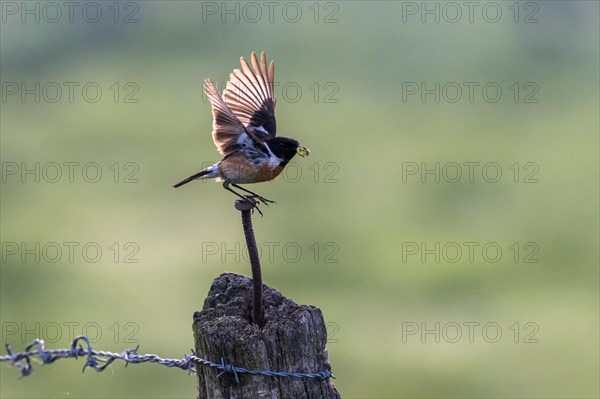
[223,53,277,141]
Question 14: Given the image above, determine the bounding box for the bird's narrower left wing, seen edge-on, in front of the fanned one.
[204,79,263,156]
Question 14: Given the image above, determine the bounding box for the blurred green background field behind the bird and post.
[0,1,600,398]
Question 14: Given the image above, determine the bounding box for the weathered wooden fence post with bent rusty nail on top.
[193,204,340,399]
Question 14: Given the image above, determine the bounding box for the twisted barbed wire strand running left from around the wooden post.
[0,335,335,383]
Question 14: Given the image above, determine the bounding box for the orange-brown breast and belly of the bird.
[219,154,284,184]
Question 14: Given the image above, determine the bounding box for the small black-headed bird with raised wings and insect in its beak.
[173,53,310,216]
